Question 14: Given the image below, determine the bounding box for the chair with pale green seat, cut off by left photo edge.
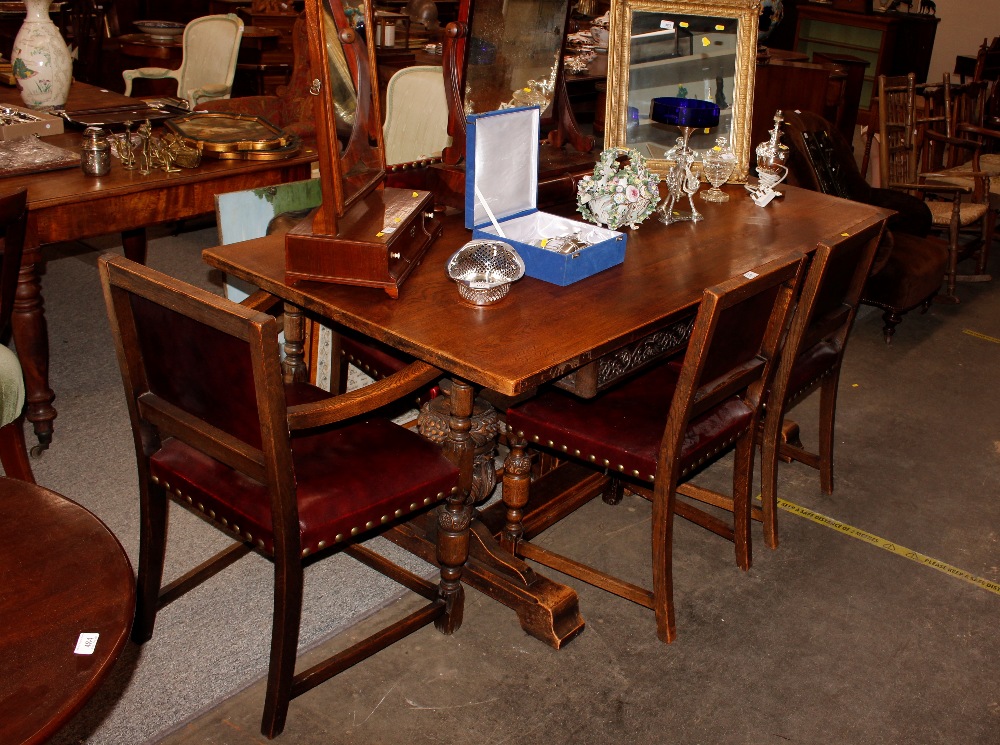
[0,189,35,483]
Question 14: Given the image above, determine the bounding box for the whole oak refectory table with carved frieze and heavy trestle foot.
[203,185,886,648]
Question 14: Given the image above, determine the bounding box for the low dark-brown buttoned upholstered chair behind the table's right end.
[785,112,948,343]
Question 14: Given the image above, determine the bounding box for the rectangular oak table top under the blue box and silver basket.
[203,185,885,395]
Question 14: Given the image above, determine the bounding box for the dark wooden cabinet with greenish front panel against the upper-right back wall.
[795,4,938,111]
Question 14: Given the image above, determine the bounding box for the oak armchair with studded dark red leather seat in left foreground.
[98,255,469,737]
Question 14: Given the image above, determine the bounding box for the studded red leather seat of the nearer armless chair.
[507,363,753,481]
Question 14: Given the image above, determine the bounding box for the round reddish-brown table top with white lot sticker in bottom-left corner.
[0,478,135,745]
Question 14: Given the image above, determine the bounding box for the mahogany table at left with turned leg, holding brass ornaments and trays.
[0,82,317,448]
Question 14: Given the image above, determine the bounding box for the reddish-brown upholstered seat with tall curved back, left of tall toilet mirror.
[198,15,316,140]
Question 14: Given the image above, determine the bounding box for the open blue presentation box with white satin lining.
[465,106,627,286]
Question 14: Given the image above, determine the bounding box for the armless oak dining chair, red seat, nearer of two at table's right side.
[502,255,803,642]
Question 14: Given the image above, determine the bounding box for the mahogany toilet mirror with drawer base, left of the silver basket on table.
[285,0,441,297]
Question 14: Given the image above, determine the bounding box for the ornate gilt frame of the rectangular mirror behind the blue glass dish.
[604,0,761,183]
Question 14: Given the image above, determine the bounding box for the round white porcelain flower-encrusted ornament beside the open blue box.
[576,148,660,230]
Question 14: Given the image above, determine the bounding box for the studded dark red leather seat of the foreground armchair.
[150,386,458,554]
